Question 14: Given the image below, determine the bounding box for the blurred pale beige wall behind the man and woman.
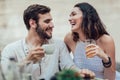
[0,0,120,70]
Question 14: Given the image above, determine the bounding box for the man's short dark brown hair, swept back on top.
[23,4,50,30]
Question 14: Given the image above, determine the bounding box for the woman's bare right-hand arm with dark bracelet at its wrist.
[97,35,116,80]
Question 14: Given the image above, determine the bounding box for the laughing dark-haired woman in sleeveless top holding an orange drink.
[64,3,116,80]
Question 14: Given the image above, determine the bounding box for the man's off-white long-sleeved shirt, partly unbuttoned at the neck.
[1,39,74,80]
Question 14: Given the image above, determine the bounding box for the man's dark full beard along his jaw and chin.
[36,24,52,39]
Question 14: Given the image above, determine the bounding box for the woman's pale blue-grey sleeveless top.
[73,41,104,78]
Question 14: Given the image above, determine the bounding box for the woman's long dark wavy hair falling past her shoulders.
[73,2,109,42]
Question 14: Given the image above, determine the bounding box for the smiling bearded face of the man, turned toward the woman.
[36,13,54,39]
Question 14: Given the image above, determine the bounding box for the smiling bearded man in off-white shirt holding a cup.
[1,4,94,80]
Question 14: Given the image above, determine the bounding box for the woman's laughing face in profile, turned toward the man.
[69,7,83,32]
